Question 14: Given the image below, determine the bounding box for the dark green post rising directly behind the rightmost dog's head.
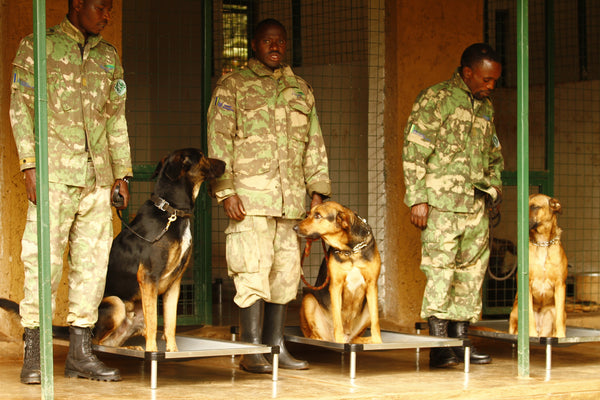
[544,0,554,196]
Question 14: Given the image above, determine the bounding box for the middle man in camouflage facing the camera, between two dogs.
[208,19,331,373]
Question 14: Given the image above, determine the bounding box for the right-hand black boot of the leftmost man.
[65,326,121,381]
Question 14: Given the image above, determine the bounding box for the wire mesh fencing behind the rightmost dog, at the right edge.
[484,0,600,314]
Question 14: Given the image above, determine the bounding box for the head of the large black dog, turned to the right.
[152,148,225,203]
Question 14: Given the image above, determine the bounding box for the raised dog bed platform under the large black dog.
[88,334,279,389]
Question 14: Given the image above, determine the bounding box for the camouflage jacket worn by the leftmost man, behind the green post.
[10,18,132,186]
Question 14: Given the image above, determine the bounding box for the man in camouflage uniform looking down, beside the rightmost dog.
[403,43,504,367]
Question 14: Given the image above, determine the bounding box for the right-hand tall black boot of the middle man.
[263,303,308,369]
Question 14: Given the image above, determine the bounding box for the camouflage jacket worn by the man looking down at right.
[403,71,504,212]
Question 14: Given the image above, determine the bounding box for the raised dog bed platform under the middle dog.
[285,326,470,379]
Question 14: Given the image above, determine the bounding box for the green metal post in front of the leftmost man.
[33,0,54,399]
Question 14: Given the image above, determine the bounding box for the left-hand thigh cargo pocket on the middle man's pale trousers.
[225,216,260,276]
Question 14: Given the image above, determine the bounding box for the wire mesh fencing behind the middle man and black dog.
[123,0,384,323]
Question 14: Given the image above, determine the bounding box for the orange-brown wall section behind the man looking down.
[384,0,483,329]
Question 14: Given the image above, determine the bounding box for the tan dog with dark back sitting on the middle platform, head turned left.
[294,201,381,343]
